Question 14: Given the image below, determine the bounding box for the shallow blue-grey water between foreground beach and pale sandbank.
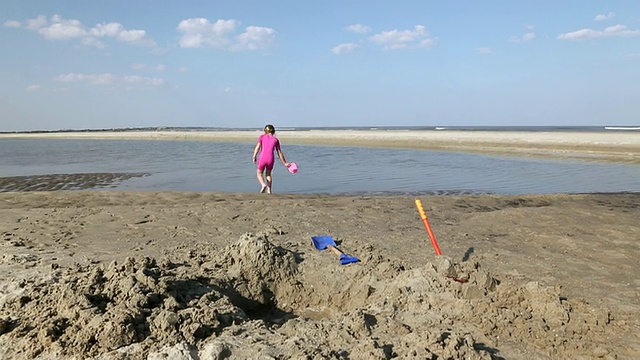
[0,139,640,194]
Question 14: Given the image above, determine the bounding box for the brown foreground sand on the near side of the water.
[0,191,640,360]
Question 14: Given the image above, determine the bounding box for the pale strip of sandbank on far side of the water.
[0,128,640,164]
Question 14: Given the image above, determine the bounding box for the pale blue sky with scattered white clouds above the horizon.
[0,0,640,131]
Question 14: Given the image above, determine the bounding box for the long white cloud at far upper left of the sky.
[11,15,155,48]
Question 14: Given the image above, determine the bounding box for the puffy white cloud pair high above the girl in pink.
[178,18,276,51]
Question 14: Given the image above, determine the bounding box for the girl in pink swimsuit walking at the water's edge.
[253,125,290,194]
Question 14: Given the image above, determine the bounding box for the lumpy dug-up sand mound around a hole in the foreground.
[0,234,611,360]
